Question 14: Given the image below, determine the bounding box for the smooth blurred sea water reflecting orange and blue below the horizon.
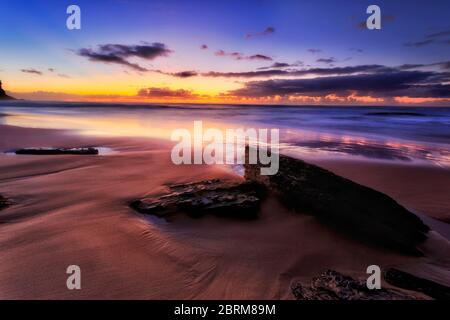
[0,101,450,168]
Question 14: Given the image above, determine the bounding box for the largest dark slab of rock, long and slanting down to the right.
[244,148,429,255]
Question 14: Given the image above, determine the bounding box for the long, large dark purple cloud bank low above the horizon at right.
[229,71,450,98]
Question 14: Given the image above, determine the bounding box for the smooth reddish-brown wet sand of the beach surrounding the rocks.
[0,126,450,299]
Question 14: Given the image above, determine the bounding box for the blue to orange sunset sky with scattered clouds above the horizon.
[0,0,450,105]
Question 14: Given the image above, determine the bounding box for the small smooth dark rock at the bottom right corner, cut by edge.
[384,268,450,300]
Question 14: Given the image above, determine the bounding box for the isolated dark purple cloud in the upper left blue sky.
[76,42,172,72]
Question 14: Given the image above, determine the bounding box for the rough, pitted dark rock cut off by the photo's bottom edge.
[292,270,417,300]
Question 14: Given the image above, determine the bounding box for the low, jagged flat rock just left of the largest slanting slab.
[130,179,263,218]
